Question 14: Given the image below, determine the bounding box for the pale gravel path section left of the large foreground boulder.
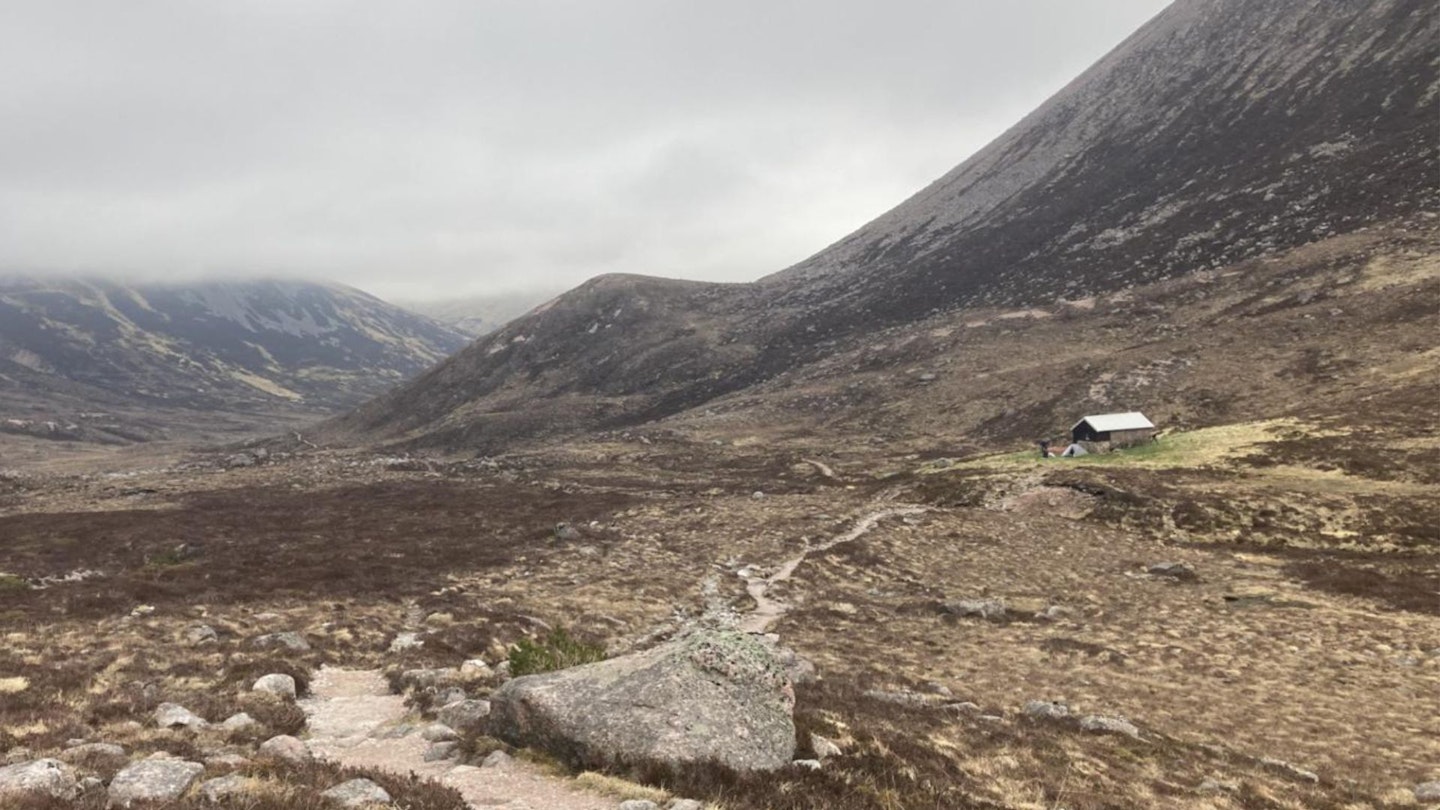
[301,667,616,810]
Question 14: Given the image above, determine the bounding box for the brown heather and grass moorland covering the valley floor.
[0,424,1440,809]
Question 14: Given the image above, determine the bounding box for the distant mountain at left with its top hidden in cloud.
[0,278,467,441]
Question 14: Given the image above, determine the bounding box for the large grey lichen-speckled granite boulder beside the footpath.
[487,631,795,771]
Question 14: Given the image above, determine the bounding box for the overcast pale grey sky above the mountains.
[0,0,1166,301]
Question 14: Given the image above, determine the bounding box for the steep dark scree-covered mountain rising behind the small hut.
[327,0,1440,450]
